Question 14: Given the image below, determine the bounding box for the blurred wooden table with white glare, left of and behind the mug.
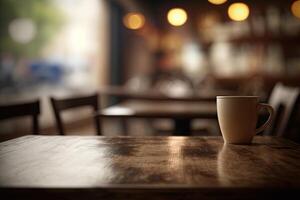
[97,100,217,135]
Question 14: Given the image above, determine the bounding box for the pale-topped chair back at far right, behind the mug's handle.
[265,83,300,137]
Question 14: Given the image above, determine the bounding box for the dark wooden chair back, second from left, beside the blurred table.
[50,94,101,135]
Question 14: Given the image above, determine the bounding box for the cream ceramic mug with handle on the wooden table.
[217,96,274,144]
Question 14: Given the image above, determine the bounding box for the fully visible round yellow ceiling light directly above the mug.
[228,3,250,21]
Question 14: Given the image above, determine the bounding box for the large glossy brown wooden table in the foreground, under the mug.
[0,136,300,200]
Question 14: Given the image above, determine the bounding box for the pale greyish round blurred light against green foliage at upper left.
[8,18,37,44]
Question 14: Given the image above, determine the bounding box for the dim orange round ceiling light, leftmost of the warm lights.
[123,13,145,30]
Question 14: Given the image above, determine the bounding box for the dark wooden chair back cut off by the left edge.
[0,100,40,134]
